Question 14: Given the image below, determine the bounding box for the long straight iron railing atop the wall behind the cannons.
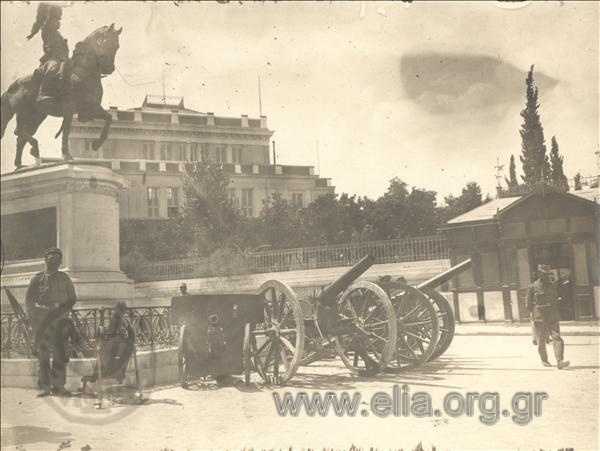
[136,235,448,282]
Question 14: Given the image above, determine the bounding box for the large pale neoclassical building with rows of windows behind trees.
[70,96,334,219]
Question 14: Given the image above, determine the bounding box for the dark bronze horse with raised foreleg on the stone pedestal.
[0,24,123,169]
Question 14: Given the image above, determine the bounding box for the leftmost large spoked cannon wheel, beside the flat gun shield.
[250,280,304,385]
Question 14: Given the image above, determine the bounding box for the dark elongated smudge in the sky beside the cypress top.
[400,53,558,114]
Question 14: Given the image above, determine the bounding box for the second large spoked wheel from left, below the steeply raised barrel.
[335,281,397,376]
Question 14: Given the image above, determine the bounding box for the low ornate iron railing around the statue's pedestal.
[0,307,179,358]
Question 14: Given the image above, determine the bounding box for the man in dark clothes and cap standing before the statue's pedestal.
[26,247,77,396]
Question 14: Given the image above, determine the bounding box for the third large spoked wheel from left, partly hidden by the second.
[386,282,439,373]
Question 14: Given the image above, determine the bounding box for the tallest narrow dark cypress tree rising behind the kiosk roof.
[519,65,550,185]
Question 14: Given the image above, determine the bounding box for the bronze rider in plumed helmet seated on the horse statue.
[27,3,69,110]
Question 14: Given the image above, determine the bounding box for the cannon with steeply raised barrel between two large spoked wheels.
[251,255,397,384]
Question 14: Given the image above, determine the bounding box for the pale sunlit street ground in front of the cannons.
[2,336,600,450]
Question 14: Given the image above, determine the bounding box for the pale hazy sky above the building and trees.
[0,1,600,202]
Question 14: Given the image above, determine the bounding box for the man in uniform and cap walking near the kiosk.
[527,265,569,370]
